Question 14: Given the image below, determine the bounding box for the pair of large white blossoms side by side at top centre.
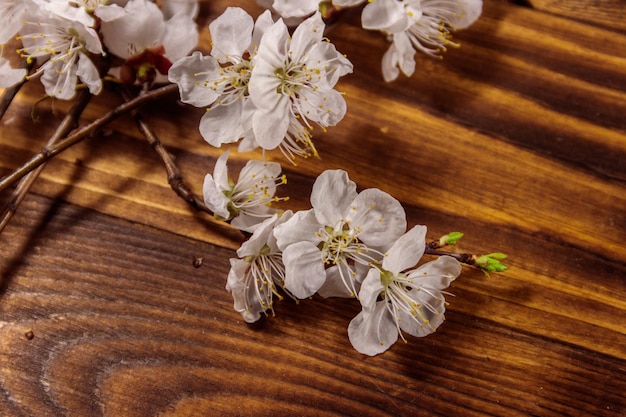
[169,7,352,159]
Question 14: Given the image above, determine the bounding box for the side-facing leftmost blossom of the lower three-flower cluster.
[226,211,293,323]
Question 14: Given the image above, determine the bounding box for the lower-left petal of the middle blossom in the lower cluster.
[283,242,326,298]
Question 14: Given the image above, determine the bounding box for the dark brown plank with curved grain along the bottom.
[0,194,626,416]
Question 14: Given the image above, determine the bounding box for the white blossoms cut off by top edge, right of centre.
[259,0,483,81]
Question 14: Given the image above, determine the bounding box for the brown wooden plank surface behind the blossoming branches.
[0,0,626,416]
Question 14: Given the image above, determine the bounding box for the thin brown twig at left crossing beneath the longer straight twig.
[0,89,92,233]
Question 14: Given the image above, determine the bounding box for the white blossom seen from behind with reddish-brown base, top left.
[100,0,198,83]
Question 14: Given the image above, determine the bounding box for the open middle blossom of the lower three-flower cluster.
[275,170,406,298]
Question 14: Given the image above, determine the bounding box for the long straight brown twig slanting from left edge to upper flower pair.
[0,84,178,192]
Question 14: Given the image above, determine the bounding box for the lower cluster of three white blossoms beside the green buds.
[218,168,461,355]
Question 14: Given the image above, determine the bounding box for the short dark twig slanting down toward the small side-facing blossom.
[122,88,213,215]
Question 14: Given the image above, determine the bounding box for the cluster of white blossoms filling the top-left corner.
[0,0,198,100]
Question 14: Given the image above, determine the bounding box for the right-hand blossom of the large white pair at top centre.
[248,12,352,153]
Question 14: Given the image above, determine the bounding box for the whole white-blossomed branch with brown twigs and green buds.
[0,0,506,355]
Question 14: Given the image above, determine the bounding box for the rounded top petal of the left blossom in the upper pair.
[209,7,254,62]
